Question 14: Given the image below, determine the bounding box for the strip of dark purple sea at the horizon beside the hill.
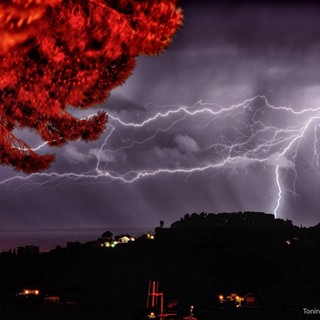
[0,227,153,252]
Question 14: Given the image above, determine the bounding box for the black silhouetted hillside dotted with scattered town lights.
[0,212,320,320]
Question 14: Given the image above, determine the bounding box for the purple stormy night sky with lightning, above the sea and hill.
[0,1,320,229]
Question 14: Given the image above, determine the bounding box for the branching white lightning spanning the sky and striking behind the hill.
[0,96,320,217]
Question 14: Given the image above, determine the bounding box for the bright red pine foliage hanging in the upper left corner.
[0,0,182,173]
